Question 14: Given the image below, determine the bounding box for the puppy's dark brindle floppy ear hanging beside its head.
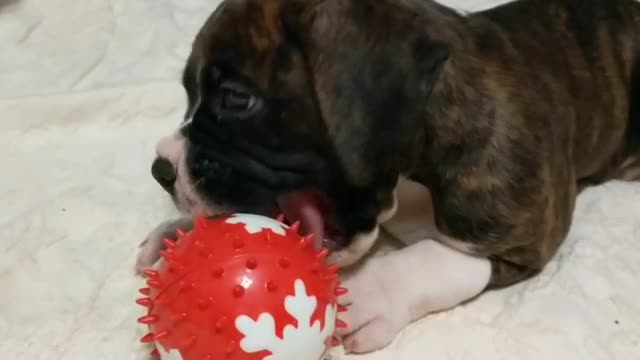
[283,0,449,186]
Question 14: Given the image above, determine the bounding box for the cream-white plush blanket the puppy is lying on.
[0,0,640,360]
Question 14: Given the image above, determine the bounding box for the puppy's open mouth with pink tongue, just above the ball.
[277,190,345,250]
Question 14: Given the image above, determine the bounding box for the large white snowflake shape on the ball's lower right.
[236,279,337,360]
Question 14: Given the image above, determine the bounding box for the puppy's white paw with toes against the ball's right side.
[337,259,410,353]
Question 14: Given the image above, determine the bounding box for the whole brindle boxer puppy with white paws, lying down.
[138,0,640,352]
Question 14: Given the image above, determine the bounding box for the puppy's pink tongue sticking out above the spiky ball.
[278,191,324,249]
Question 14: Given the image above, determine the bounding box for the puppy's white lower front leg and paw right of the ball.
[340,240,491,353]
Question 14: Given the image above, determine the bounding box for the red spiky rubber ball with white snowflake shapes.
[137,214,347,360]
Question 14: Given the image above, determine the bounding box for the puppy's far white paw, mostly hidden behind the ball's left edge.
[135,218,193,275]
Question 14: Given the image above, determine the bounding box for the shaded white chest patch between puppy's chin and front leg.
[382,179,441,245]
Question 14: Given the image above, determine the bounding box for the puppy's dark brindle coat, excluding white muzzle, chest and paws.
[178,0,640,287]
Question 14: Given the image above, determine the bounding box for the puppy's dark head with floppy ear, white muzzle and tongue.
[152,0,447,264]
